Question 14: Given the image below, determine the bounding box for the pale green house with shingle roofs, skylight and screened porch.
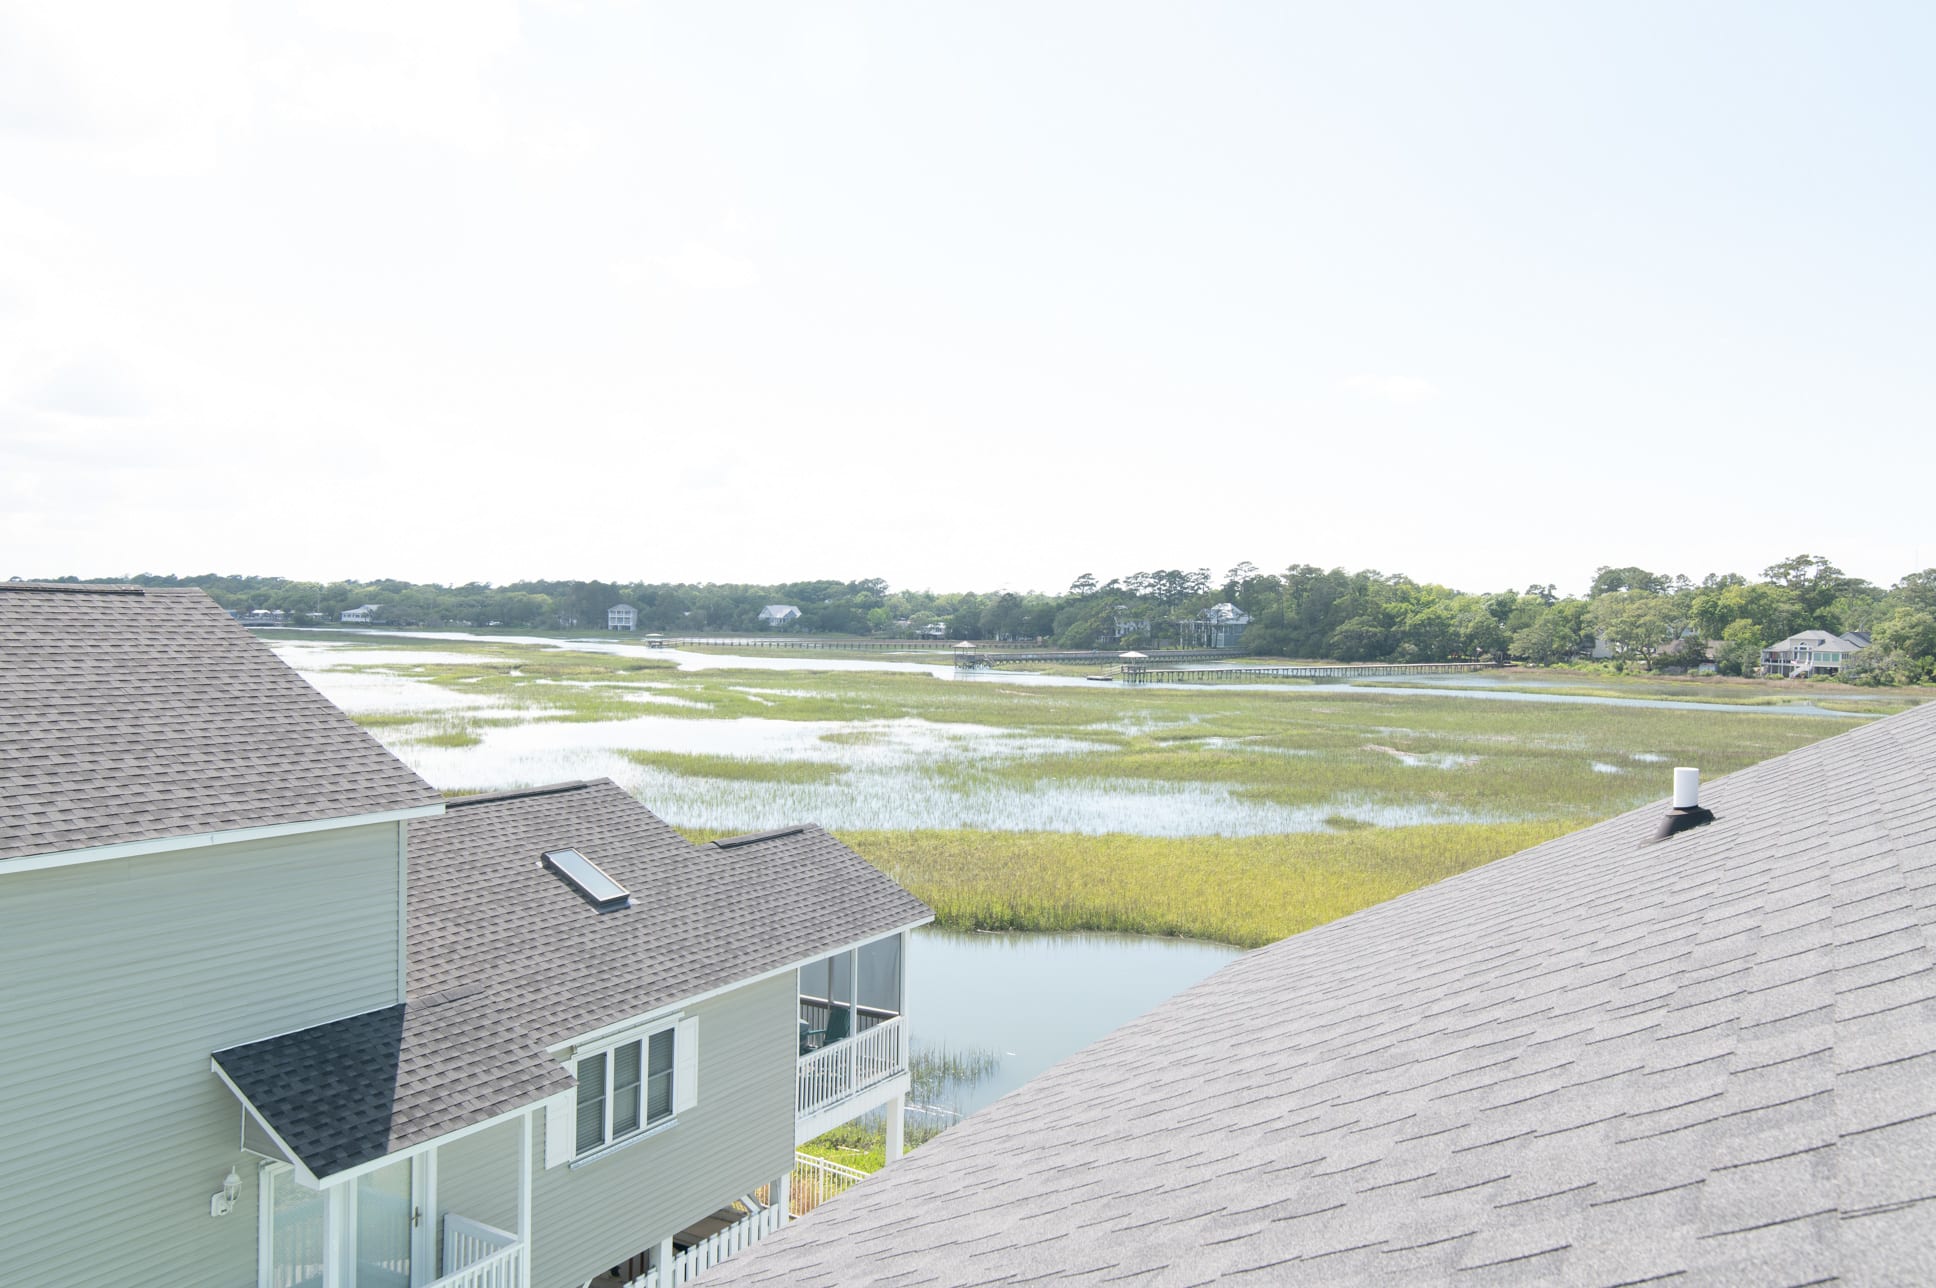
[0,583,929,1288]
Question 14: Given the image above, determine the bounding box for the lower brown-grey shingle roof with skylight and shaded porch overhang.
[215,779,931,1176]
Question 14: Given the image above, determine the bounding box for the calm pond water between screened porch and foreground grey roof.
[906,926,1239,1121]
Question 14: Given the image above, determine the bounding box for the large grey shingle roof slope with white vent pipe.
[709,703,1936,1288]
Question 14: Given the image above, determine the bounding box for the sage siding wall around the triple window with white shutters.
[526,972,800,1288]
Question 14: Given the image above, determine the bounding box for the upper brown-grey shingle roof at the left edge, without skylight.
[0,583,438,862]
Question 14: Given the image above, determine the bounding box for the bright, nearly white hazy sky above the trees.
[0,0,1936,591]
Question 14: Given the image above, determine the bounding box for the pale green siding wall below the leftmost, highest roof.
[0,823,401,1288]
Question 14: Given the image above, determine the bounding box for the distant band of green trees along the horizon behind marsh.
[71,554,1936,684]
